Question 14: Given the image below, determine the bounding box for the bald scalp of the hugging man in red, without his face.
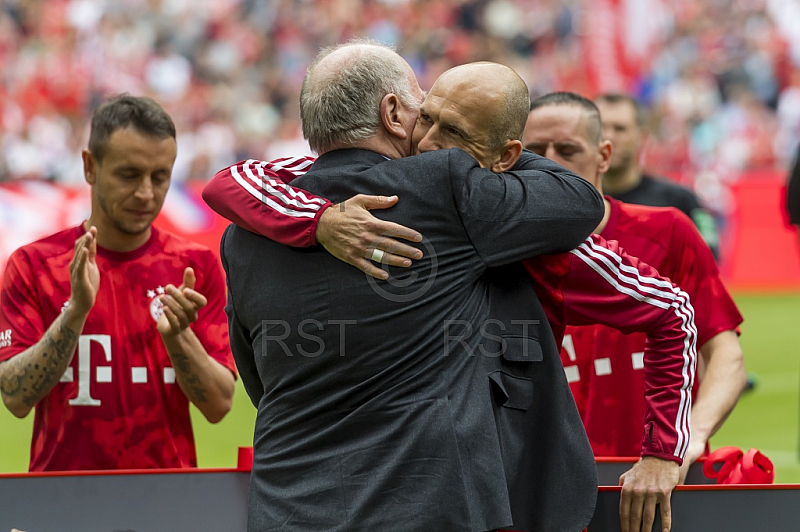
[431,62,530,148]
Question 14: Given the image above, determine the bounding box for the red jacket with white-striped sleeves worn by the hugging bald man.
[203,158,696,463]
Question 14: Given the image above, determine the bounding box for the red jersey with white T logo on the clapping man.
[0,225,235,471]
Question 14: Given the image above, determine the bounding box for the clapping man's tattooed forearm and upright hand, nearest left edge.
[0,227,100,418]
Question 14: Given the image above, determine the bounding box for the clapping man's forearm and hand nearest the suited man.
[158,268,236,423]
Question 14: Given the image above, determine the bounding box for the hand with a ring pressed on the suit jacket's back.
[317,194,422,279]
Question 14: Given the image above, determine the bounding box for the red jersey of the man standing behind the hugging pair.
[561,197,742,456]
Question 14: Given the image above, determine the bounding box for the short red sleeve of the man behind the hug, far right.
[668,212,743,347]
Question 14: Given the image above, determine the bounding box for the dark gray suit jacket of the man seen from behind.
[221,150,603,532]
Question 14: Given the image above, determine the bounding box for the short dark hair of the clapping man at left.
[89,93,175,161]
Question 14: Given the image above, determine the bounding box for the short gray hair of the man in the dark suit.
[300,40,420,153]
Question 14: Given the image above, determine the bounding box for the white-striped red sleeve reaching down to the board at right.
[561,235,697,463]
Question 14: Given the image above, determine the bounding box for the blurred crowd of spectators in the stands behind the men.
[0,0,800,202]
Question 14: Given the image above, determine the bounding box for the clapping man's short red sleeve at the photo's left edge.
[0,250,45,362]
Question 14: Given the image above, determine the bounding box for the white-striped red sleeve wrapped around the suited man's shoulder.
[203,157,332,247]
